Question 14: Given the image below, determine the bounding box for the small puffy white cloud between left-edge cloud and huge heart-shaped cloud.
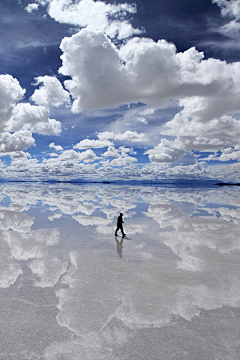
[30,76,70,107]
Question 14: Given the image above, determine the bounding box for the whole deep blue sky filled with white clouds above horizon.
[0,0,240,181]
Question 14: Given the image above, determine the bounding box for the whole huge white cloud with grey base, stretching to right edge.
[59,29,239,116]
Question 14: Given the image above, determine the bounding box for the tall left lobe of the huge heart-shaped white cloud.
[59,29,129,113]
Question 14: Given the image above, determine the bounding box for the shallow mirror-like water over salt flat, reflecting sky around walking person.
[0,183,240,360]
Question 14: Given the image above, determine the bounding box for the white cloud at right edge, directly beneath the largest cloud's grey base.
[162,102,240,156]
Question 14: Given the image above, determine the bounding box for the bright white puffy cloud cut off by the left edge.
[0,75,61,158]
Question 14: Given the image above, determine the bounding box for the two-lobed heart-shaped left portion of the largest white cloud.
[60,29,181,112]
